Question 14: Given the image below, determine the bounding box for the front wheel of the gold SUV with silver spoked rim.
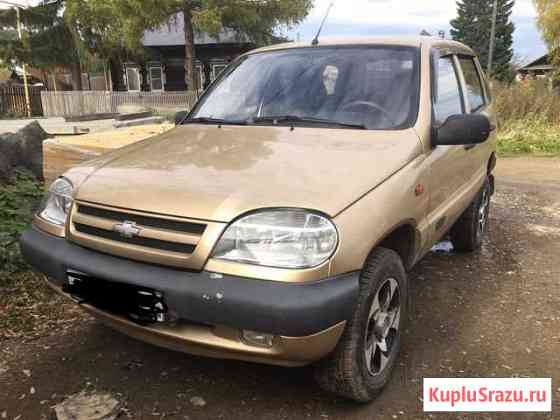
[315,248,408,402]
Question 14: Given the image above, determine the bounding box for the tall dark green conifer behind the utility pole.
[451,0,515,82]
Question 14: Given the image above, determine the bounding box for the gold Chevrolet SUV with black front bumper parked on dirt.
[21,37,496,401]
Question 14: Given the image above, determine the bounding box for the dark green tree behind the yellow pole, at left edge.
[0,1,82,90]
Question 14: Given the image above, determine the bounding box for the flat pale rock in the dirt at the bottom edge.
[54,391,120,420]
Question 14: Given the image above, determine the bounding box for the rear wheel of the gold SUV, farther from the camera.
[450,178,492,252]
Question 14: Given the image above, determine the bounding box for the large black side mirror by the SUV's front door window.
[432,114,492,146]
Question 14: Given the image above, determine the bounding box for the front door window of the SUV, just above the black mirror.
[433,56,463,124]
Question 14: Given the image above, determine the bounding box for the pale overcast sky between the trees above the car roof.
[288,0,546,61]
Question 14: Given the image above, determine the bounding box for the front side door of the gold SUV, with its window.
[427,50,472,242]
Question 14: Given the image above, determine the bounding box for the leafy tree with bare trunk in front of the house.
[66,0,313,87]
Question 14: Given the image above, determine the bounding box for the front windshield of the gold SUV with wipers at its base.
[190,46,419,130]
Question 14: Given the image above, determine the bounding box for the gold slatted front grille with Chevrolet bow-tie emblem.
[68,202,219,269]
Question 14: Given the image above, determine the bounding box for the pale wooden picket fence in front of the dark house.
[41,91,197,117]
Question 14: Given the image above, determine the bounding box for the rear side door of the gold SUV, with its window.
[457,55,495,178]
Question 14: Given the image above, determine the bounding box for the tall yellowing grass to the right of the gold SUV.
[494,81,560,156]
